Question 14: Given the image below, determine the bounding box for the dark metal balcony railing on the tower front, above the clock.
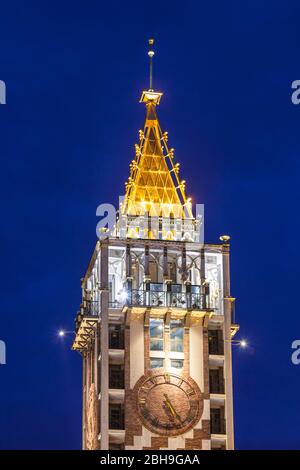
[125,289,207,310]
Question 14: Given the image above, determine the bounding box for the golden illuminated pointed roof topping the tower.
[122,90,193,218]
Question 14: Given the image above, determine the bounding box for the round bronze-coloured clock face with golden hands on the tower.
[136,371,203,436]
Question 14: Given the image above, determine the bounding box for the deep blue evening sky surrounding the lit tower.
[0,0,300,449]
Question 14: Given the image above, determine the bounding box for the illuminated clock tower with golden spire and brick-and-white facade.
[73,40,238,450]
